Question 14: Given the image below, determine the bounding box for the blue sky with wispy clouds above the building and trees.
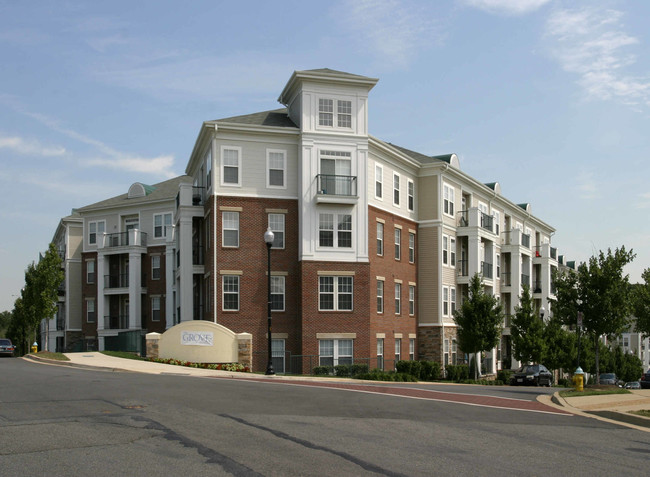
[0,0,650,311]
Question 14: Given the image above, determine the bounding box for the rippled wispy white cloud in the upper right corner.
[546,8,650,106]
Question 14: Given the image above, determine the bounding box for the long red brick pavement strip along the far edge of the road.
[216,378,573,416]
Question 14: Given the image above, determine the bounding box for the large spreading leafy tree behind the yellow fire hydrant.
[554,247,635,382]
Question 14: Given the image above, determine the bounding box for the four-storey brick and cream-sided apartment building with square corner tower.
[48,69,557,373]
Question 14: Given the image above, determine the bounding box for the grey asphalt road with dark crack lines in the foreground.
[0,359,650,476]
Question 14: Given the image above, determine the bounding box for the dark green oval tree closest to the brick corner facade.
[454,273,503,378]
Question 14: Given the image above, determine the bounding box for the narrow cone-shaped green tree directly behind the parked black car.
[510,285,546,363]
